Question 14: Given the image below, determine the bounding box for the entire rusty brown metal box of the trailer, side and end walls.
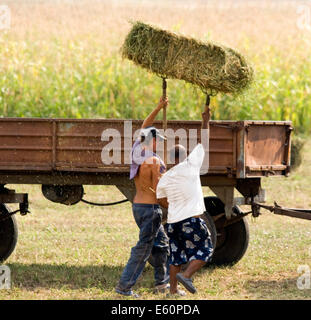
[0,118,290,178]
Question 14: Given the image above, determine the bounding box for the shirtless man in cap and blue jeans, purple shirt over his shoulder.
[116,98,169,297]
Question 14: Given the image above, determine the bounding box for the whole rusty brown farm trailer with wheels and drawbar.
[0,118,311,265]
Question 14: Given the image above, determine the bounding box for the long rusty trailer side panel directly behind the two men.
[55,120,234,173]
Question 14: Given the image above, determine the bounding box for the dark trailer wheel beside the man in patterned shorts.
[204,197,249,266]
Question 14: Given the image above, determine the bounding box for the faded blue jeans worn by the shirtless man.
[118,203,169,291]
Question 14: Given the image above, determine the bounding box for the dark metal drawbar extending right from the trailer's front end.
[252,202,311,220]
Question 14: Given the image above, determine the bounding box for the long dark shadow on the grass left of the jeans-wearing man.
[7,263,124,290]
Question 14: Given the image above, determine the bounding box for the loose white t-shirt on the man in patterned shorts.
[157,144,205,223]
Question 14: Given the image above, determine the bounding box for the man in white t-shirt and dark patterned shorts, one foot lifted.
[156,113,213,294]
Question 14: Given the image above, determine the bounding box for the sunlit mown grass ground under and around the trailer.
[0,139,311,299]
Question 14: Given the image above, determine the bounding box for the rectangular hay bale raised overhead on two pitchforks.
[121,22,253,93]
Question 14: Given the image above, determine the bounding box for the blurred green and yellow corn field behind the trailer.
[0,0,311,134]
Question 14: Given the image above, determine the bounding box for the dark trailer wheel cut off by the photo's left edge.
[0,203,18,263]
